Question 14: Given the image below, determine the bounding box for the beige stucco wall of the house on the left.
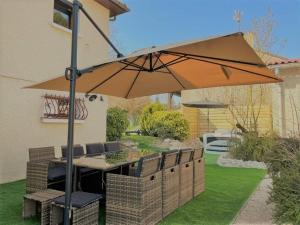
[0,0,109,183]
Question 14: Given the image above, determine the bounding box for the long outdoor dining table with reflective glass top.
[52,151,141,191]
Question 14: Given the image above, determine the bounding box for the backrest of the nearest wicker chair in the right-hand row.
[135,153,161,177]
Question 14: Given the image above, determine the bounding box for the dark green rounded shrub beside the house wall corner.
[106,107,129,141]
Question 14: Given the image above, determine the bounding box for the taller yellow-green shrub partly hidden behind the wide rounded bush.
[140,103,165,136]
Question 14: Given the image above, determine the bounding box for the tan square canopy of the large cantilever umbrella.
[29,33,281,98]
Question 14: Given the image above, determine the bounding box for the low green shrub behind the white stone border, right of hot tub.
[229,133,275,162]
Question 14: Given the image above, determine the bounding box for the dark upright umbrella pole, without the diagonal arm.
[64,0,80,225]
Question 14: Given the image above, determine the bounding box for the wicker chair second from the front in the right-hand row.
[161,150,179,217]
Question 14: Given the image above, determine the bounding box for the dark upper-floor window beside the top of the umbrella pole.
[53,0,72,29]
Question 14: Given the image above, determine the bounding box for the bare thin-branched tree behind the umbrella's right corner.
[225,9,279,133]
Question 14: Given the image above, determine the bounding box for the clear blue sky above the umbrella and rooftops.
[111,0,300,58]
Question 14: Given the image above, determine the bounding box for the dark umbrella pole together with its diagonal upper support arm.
[62,0,123,225]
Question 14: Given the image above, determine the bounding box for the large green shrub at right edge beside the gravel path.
[266,139,300,224]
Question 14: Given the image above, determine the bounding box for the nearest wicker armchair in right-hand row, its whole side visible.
[106,154,162,225]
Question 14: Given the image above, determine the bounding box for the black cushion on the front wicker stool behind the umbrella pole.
[54,191,103,208]
